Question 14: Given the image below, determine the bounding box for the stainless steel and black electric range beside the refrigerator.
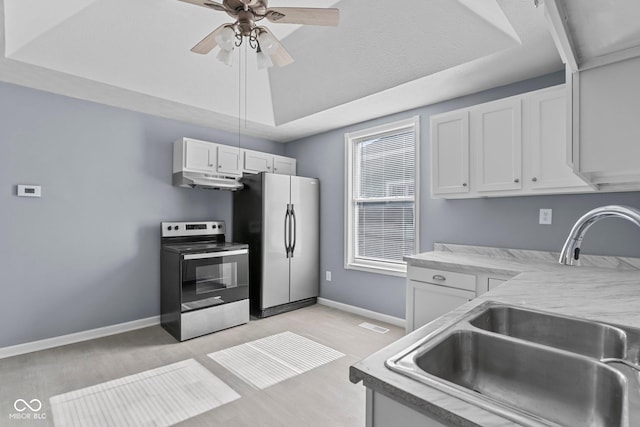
[160,221,249,341]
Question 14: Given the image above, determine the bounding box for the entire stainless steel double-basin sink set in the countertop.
[387,303,640,427]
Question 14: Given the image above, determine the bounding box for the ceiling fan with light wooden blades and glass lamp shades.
[180,0,340,68]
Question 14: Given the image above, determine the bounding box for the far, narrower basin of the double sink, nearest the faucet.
[470,306,627,359]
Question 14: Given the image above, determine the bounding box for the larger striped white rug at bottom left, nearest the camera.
[49,359,240,427]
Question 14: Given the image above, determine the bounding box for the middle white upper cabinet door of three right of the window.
[471,98,522,191]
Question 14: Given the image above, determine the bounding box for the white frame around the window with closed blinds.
[344,116,420,277]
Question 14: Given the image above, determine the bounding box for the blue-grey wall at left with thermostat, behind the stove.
[0,83,284,348]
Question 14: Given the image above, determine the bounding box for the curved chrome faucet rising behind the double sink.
[558,205,640,265]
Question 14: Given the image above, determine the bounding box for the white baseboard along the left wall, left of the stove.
[0,316,160,359]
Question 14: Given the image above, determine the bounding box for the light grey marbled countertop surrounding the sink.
[350,247,640,427]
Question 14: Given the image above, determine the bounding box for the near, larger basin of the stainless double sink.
[415,331,625,427]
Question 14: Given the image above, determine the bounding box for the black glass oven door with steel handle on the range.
[181,249,249,312]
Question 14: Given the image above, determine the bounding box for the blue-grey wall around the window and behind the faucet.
[286,73,640,318]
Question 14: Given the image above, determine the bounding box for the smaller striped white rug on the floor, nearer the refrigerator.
[208,332,344,389]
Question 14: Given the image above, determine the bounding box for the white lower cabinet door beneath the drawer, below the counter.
[407,280,475,332]
